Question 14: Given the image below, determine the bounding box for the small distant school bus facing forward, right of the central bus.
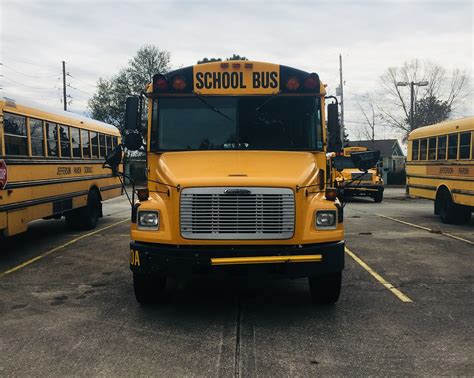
[335,147,384,202]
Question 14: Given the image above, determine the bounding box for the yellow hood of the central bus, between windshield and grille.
[153,151,317,188]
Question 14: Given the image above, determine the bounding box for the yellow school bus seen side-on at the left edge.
[0,98,121,236]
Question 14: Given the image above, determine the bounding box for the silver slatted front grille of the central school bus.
[180,187,295,240]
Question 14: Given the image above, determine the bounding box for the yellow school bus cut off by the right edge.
[407,117,474,223]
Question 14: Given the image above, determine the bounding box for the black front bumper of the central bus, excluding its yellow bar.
[130,241,344,277]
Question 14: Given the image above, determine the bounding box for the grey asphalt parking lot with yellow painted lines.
[0,189,474,376]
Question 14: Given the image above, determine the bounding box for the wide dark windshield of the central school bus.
[150,96,323,151]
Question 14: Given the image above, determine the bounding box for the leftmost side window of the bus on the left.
[3,113,28,156]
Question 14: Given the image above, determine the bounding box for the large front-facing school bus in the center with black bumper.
[107,61,378,303]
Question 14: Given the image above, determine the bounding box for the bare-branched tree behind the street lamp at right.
[378,59,470,137]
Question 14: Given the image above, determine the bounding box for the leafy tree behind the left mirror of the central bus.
[88,45,171,130]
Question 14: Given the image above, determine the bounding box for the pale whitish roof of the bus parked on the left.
[0,93,120,136]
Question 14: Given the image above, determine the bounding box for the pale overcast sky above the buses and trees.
[0,0,474,139]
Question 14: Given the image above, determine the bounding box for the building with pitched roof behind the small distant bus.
[348,139,406,184]
